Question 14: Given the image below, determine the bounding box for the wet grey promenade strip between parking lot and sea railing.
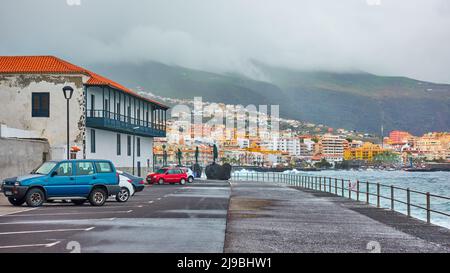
[225,182,450,253]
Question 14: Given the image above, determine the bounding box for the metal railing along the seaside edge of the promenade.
[231,172,450,224]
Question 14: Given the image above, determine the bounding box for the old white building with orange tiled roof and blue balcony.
[0,56,168,175]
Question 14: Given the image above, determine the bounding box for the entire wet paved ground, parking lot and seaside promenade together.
[0,181,450,253]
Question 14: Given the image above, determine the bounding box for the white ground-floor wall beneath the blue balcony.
[86,128,153,168]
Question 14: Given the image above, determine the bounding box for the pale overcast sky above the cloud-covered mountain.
[0,0,450,83]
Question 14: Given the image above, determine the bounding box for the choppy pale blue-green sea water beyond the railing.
[233,170,450,228]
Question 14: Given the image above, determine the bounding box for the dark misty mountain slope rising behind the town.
[89,62,450,135]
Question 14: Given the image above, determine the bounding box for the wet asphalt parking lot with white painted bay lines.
[0,181,230,253]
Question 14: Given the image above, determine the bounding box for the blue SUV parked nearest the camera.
[2,160,120,207]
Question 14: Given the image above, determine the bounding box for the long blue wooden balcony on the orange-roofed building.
[86,110,166,137]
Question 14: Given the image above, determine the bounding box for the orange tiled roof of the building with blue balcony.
[0,56,169,108]
